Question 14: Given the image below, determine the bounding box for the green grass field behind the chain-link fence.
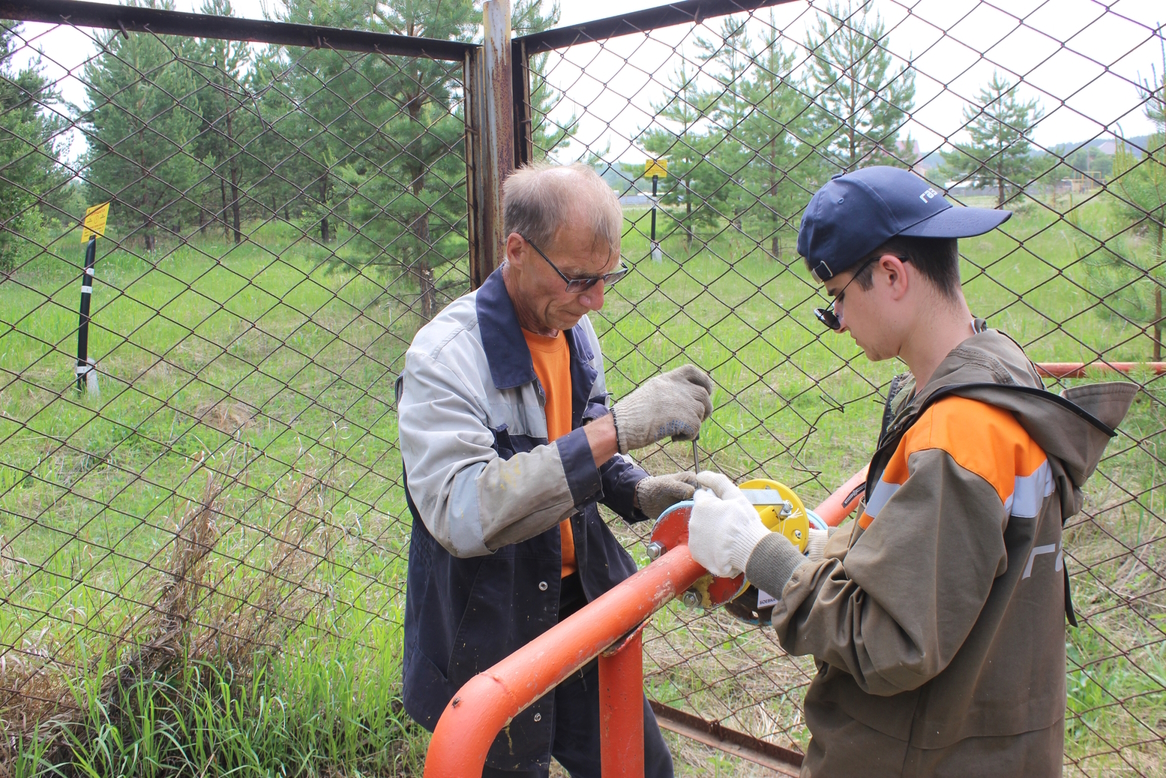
[0,199,1166,776]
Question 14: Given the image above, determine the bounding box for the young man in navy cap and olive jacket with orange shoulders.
[689,167,1136,776]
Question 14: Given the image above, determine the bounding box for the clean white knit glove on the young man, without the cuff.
[688,470,770,577]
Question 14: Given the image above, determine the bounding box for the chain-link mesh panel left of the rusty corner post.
[0,10,469,769]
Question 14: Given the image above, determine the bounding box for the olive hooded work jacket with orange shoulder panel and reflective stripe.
[760,330,1137,776]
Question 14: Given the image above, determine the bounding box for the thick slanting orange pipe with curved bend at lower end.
[424,546,705,778]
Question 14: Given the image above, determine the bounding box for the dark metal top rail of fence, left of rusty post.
[0,0,478,62]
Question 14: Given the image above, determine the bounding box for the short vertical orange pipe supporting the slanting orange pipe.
[599,629,644,778]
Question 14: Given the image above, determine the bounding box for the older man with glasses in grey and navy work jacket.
[396,164,712,777]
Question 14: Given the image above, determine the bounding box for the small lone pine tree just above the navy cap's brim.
[941,73,1045,208]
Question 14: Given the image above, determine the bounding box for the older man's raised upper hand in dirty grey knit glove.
[611,365,712,454]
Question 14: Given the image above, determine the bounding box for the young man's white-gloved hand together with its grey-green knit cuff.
[688,471,807,593]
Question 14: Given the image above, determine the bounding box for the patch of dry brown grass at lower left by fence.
[0,456,335,777]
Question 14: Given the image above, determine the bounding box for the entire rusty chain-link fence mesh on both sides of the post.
[0,0,1166,776]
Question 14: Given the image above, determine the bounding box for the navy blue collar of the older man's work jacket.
[475,267,595,390]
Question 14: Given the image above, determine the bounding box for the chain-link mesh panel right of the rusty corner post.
[532,2,1166,775]
